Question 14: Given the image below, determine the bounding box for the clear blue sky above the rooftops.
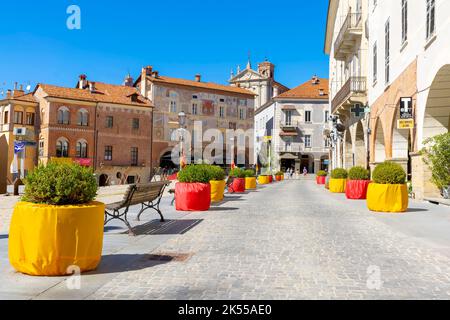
[0,0,328,94]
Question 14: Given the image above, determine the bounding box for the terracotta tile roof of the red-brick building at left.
[38,82,153,107]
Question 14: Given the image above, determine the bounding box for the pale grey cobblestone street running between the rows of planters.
[89,181,450,299]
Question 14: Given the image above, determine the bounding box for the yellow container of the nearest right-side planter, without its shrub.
[367,183,409,213]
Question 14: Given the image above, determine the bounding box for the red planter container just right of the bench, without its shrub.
[175,182,211,211]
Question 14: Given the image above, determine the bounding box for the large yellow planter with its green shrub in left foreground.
[8,162,105,276]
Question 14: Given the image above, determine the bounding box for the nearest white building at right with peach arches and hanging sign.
[368,0,450,198]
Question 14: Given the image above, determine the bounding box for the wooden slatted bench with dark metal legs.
[105,181,171,235]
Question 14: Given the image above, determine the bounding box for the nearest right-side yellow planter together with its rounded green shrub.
[367,162,409,212]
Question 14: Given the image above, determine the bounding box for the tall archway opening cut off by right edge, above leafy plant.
[422,64,450,142]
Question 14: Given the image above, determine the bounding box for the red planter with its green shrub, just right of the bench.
[175,164,211,211]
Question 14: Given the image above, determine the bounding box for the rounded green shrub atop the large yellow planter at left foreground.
[21,162,97,205]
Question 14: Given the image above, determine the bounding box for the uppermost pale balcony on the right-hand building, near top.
[334,11,363,60]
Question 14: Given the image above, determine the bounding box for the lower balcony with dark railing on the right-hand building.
[331,77,367,114]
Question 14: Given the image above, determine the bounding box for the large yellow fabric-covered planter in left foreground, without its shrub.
[8,202,105,276]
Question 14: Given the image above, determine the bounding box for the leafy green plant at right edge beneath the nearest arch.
[422,133,450,199]
